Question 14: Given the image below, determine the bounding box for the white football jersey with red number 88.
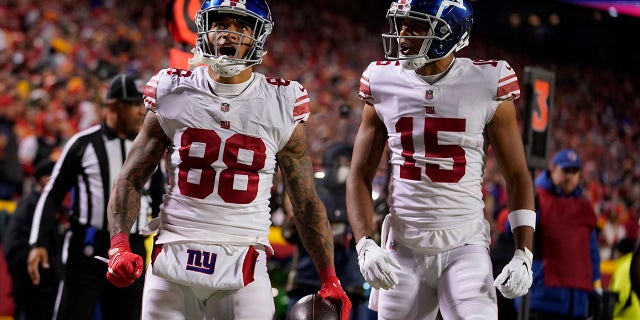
[144,66,309,246]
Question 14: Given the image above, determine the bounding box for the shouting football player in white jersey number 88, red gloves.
[102,0,351,320]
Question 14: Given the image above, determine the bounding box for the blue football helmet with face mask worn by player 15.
[382,0,473,70]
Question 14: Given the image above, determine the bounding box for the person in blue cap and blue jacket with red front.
[507,149,602,320]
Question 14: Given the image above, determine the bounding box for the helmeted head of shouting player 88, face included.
[189,0,273,77]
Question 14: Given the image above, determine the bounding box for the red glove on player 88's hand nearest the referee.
[107,233,143,288]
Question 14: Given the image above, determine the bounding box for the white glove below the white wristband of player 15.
[493,248,533,299]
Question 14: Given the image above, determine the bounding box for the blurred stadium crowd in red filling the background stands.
[0,0,640,315]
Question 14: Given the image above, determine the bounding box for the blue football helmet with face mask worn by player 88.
[189,0,273,77]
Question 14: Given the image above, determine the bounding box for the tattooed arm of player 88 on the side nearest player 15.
[278,125,333,270]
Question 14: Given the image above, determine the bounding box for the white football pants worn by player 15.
[378,239,498,320]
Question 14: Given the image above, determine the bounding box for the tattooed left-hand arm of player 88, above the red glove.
[107,112,169,235]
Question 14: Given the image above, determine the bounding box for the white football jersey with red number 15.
[359,58,520,251]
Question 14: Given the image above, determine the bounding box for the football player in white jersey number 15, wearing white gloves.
[347,0,535,320]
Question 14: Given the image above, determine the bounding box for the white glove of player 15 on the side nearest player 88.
[356,237,400,290]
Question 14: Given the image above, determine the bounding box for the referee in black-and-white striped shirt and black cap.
[27,74,164,320]
